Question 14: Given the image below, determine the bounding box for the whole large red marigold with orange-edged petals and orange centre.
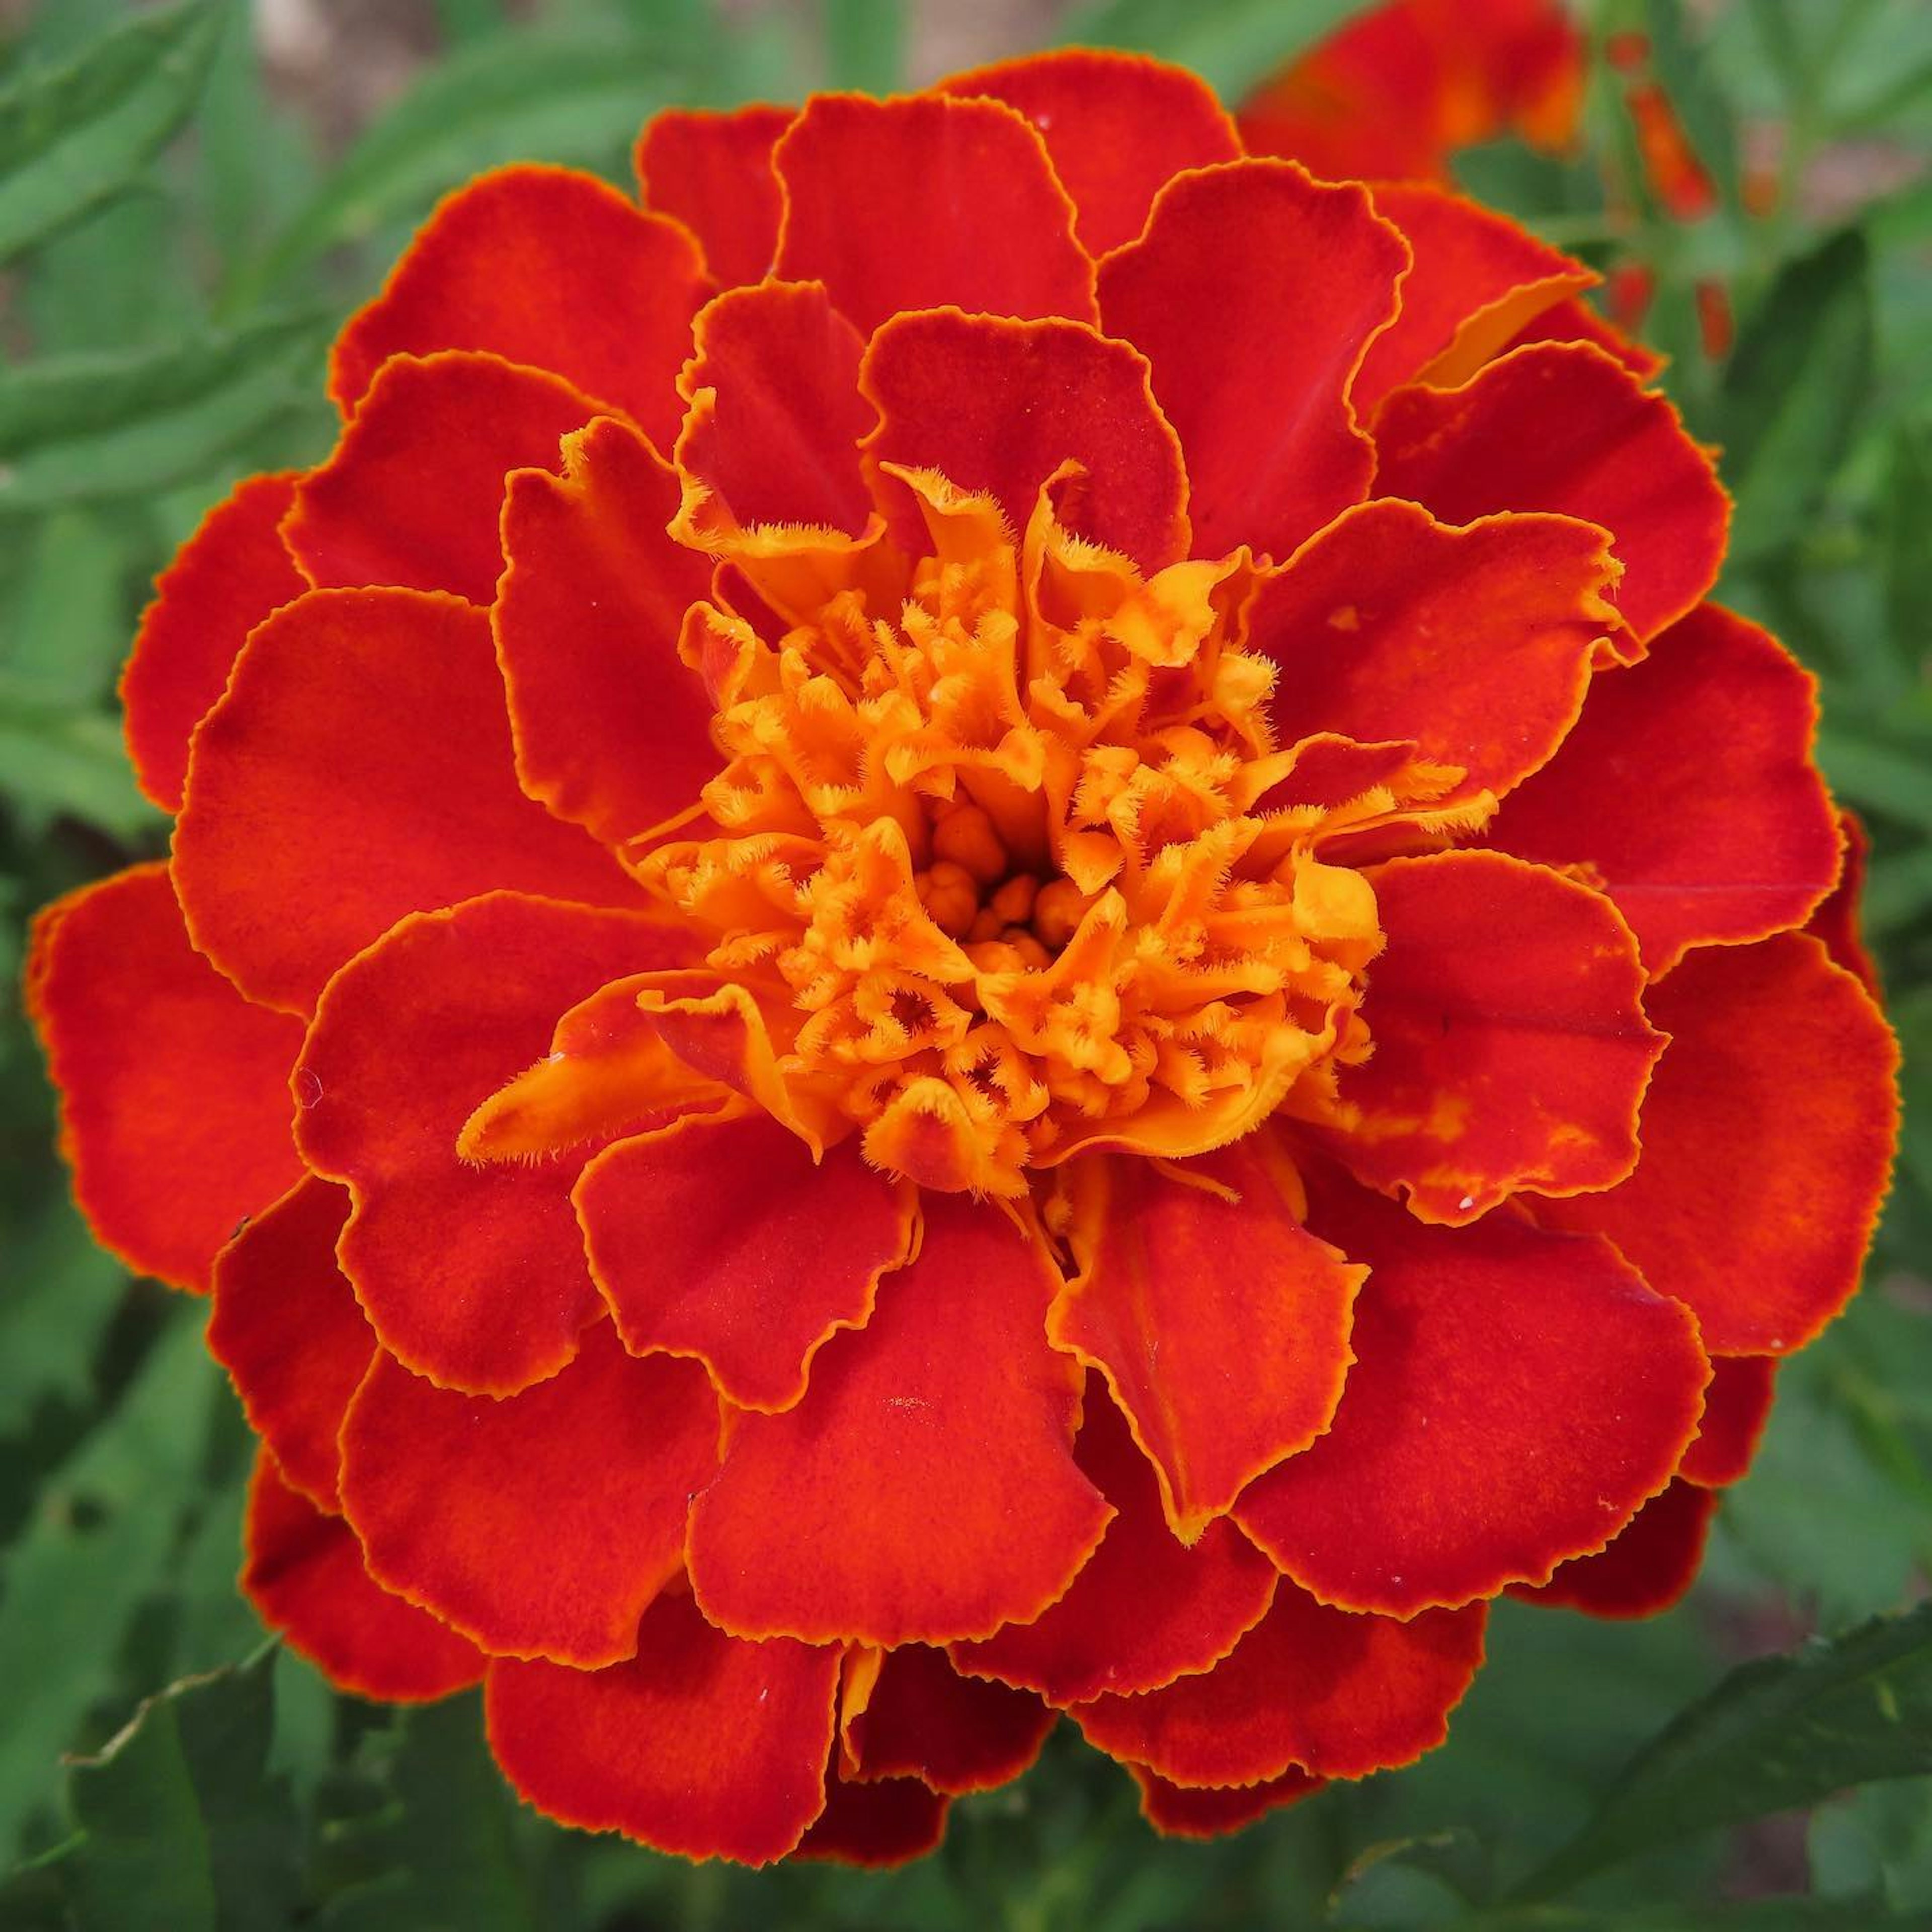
[31,54,1893,1863]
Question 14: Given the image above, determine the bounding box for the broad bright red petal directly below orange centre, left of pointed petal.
[690,1196,1113,1646]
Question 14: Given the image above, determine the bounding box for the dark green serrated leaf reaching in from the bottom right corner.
[1518,1603,1932,1899]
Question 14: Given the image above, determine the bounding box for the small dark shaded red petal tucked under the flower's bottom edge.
[842,1644,1059,1797]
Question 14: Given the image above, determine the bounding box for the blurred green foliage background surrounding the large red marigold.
[0,0,1932,1932]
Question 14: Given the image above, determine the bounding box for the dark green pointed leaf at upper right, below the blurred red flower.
[1718,230,1872,558]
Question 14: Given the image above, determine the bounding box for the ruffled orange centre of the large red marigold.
[635,473,1393,1196]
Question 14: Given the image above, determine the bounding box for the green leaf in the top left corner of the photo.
[0,0,222,257]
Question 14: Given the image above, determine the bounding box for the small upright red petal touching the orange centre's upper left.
[678,282,873,535]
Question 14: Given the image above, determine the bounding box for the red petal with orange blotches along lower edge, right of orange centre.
[1316,852,1663,1225]
